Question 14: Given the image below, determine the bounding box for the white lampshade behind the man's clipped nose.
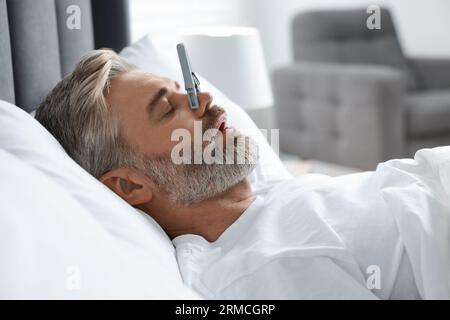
[180,27,273,110]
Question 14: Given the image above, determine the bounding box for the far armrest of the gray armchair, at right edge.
[408,58,450,89]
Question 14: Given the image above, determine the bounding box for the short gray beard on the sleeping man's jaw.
[141,133,258,206]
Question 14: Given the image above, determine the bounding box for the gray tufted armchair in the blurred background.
[272,9,450,169]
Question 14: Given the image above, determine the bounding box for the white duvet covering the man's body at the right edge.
[373,146,450,299]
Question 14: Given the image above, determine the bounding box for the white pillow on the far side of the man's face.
[120,35,292,191]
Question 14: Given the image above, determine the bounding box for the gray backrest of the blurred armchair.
[292,8,416,88]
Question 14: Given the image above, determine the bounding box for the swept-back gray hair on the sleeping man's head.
[36,49,135,178]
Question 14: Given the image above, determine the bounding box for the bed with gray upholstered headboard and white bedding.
[0,0,450,299]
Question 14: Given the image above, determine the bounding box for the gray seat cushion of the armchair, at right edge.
[405,90,450,137]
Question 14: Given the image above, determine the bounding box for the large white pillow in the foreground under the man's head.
[0,101,199,299]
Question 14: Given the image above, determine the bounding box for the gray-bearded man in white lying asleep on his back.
[36,50,450,299]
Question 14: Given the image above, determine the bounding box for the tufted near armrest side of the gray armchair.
[272,62,407,169]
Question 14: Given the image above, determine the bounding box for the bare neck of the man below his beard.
[142,179,255,242]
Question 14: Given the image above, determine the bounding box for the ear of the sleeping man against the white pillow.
[100,167,153,206]
